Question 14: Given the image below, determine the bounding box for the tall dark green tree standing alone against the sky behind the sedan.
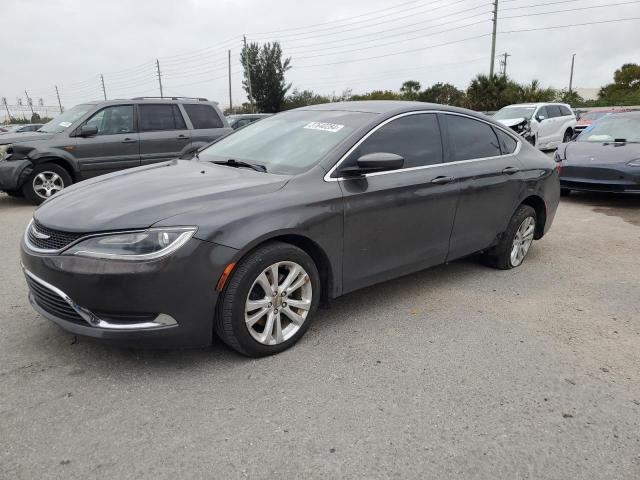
[240,42,291,113]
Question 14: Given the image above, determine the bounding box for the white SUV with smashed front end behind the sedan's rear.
[494,103,576,150]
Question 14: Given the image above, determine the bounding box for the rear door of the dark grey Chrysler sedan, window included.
[441,113,522,260]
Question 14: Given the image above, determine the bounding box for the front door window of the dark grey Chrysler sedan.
[343,113,442,168]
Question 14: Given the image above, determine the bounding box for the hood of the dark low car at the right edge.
[563,142,640,165]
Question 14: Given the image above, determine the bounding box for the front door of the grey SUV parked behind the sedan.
[72,105,140,179]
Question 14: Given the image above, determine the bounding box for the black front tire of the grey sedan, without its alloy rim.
[219,242,321,357]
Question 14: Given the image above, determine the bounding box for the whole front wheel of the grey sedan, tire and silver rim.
[214,242,320,357]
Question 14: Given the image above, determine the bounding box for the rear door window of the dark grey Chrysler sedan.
[444,115,501,162]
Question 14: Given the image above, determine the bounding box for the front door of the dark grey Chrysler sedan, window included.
[337,113,458,291]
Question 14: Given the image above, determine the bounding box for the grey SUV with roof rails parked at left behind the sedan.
[0,97,232,204]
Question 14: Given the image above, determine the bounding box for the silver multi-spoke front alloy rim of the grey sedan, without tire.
[245,262,313,345]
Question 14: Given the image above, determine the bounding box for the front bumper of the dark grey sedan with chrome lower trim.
[22,239,237,348]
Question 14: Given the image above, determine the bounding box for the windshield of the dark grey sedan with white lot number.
[198,110,375,174]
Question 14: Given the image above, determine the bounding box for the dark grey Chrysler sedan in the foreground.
[22,101,560,356]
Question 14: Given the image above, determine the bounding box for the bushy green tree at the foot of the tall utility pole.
[467,74,519,112]
